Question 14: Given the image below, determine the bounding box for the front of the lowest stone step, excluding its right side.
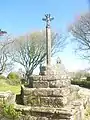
[16,106,74,120]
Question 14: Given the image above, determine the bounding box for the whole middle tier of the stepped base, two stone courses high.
[23,87,70,107]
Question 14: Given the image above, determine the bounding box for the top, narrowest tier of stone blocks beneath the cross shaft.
[29,75,70,88]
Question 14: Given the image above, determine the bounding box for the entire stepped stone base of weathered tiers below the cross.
[16,74,87,120]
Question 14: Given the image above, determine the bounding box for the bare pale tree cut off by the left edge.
[0,36,12,74]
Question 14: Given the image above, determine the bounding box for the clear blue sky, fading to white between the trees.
[0,0,89,71]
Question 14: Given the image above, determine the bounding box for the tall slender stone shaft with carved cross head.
[42,14,54,66]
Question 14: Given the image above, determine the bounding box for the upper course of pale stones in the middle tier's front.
[23,87,70,97]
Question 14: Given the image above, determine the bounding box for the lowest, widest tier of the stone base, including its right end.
[15,102,84,120]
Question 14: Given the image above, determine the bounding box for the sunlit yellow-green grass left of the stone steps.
[0,79,21,94]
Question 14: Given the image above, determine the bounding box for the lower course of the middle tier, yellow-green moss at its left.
[24,96,68,107]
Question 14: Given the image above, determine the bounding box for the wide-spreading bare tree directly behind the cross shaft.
[11,31,66,79]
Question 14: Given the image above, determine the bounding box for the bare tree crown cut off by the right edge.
[69,12,90,61]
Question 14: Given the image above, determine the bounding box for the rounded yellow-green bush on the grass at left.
[7,72,21,85]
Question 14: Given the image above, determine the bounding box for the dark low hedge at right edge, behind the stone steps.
[71,80,90,88]
